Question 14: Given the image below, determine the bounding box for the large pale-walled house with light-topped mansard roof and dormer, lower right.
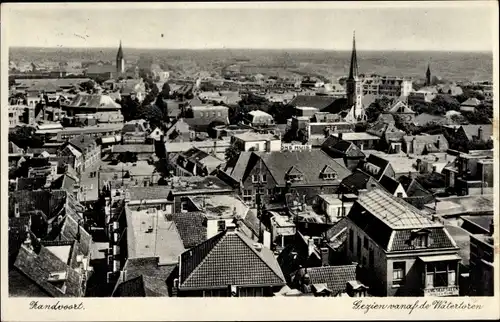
[347,190,461,296]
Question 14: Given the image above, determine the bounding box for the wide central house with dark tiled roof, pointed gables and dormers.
[219,150,350,205]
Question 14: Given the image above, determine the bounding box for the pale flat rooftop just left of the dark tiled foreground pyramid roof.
[125,208,185,264]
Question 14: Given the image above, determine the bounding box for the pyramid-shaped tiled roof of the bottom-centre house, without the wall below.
[179,231,286,289]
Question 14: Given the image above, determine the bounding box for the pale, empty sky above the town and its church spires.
[2,2,498,51]
